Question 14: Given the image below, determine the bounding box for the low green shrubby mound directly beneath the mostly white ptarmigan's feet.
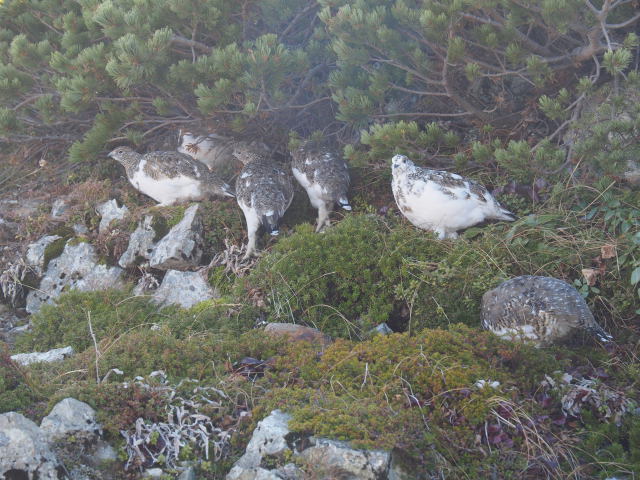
[238,213,617,338]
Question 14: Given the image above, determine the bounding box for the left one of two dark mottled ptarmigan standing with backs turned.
[233,143,293,260]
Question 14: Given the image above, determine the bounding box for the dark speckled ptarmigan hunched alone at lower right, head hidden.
[481,275,611,346]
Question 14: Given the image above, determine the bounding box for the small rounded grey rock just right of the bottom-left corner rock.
[40,398,102,441]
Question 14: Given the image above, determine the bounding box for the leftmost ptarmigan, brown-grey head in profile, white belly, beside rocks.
[109,147,234,206]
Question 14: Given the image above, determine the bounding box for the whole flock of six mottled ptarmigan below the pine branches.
[109,132,611,346]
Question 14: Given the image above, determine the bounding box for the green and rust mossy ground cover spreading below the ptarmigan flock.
[0,129,640,479]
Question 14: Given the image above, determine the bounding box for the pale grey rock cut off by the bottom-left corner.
[0,412,63,480]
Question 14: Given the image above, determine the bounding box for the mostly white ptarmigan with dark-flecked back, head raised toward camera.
[391,155,514,239]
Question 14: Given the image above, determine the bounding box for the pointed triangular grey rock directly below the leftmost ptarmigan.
[149,205,203,270]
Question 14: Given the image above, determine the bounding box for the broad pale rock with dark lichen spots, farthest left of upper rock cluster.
[27,242,122,313]
